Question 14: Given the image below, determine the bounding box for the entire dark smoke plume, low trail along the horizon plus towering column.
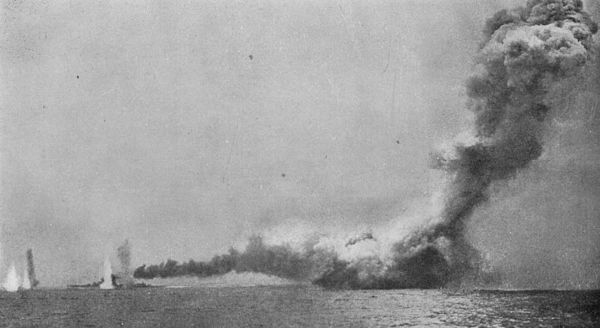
[135,0,598,288]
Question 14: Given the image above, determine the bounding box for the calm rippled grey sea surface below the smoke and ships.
[0,286,600,327]
